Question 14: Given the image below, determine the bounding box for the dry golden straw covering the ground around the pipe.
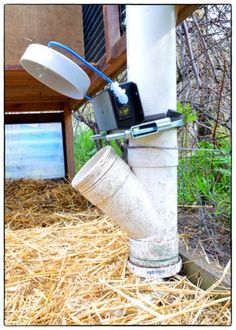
[5,181,230,325]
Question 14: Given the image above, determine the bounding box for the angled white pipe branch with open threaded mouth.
[71,147,164,239]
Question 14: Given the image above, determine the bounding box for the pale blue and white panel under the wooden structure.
[5,123,65,179]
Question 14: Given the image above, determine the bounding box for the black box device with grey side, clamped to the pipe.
[91,82,144,132]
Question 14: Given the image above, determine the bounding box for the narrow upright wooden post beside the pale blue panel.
[64,103,75,180]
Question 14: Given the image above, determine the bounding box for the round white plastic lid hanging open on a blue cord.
[20,44,91,99]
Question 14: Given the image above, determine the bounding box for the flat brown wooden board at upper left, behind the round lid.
[4,4,84,65]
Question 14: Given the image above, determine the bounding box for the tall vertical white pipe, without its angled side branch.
[126,5,181,278]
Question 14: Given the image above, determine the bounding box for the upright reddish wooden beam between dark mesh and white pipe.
[103,5,120,63]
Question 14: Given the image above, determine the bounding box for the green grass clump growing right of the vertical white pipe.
[178,137,231,222]
